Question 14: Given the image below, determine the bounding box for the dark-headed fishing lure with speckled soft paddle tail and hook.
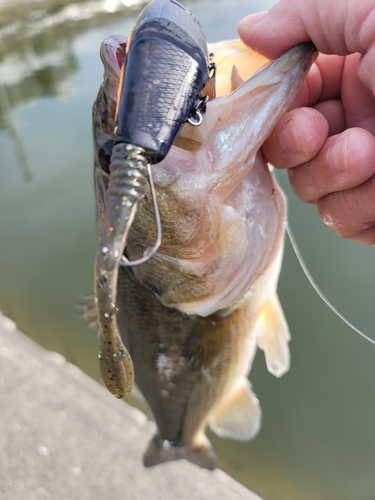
[95,0,213,398]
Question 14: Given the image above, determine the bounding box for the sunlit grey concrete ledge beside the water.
[0,315,261,500]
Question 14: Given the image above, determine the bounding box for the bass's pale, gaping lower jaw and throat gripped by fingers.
[127,44,316,316]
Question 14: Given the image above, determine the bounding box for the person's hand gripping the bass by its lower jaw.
[238,0,375,244]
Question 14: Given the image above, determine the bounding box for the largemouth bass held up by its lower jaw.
[93,1,315,469]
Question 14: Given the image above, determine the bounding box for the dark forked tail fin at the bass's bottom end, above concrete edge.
[143,435,217,470]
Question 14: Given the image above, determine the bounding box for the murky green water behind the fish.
[0,0,375,500]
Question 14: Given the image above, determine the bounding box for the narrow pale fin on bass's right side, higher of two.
[256,292,290,377]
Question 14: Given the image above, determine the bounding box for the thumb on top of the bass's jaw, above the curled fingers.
[238,0,375,59]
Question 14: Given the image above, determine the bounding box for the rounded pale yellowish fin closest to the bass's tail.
[209,378,262,441]
